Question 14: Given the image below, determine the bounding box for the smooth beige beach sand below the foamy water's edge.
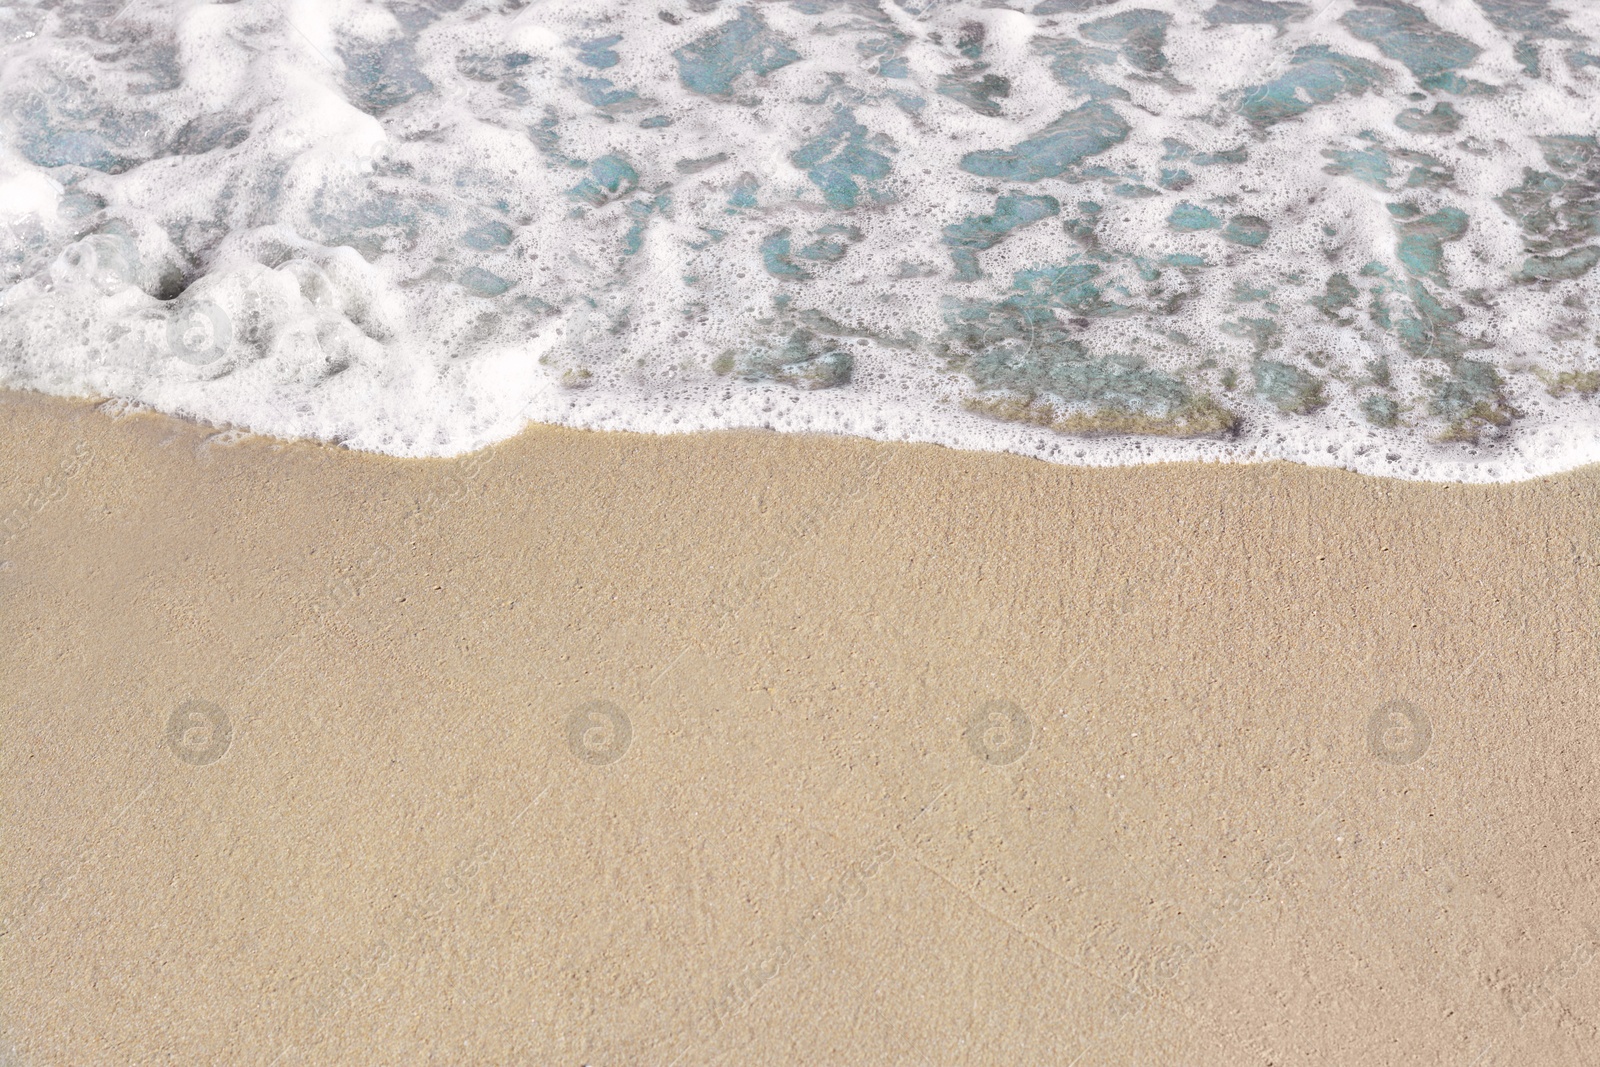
[0,394,1600,1067]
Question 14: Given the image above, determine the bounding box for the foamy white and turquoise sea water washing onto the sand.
[0,0,1600,482]
